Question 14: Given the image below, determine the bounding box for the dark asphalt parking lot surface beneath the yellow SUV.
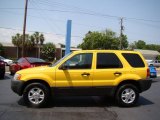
[0,72,160,120]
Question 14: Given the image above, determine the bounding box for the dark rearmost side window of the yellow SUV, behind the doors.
[122,53,145,68]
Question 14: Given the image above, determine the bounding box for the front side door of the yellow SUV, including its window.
[56,53,93,88]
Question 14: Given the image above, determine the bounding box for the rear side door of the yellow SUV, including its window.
[93,52,124,86]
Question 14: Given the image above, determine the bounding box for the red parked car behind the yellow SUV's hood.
[9,57,50,75]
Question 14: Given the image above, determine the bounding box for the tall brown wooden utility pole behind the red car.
[22,0,28,57]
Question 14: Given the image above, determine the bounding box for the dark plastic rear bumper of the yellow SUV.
[138,79,152,92]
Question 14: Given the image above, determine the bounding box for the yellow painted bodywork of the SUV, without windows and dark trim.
[17,50,148,87]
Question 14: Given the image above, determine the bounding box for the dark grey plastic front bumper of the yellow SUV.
[11,79,25,96]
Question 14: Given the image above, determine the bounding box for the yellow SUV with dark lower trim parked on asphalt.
[11,50,152,107]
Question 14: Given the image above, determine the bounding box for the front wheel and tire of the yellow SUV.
[23,83,50,108]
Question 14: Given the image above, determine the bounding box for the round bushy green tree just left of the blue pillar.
[41,42,56,61]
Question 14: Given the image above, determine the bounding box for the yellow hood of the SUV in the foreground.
[17,66,55,74]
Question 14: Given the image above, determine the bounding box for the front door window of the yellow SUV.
[63,53,93,69]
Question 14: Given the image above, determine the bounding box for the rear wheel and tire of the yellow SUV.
[116,84,139,107]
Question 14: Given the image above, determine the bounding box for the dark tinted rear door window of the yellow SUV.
[97,53,122,69]
